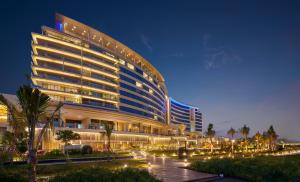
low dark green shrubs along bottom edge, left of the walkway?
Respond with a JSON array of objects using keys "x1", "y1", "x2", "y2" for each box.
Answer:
[{"x1": 50, "y1": 167, "x2": 160, "y2": 182}]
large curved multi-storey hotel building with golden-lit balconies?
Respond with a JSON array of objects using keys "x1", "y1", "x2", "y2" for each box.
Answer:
[{"x1": 0, "y1": 14, "x2": 202, "y2": 149}]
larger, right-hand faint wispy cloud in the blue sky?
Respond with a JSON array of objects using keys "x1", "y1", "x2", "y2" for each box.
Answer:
[{"x1": 202, "y1": 34, "x2": 243, "y2": 70}]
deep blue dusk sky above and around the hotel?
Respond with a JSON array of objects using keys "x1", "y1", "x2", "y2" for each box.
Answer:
[{"x1": 0, "y1": 0, "x2": 300, "y2": 140}]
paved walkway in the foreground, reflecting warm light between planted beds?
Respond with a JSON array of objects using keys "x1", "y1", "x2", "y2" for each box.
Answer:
[{"x1": 146, "y1": 156, "x2": 216, "y2": 182}]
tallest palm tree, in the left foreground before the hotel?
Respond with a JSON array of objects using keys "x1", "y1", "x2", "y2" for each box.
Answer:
[{"x1": 0, "y1": 85, "x2": 63, "y2": 182}]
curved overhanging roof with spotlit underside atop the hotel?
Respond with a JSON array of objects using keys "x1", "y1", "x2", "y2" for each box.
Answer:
[{"x1": 55, "y1": 13, "x2": 165, "y2": 82}]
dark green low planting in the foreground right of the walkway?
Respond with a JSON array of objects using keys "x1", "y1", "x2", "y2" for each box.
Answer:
[{"x1": 190, "y1": 155, "x2": 300, "y2": 182}]
